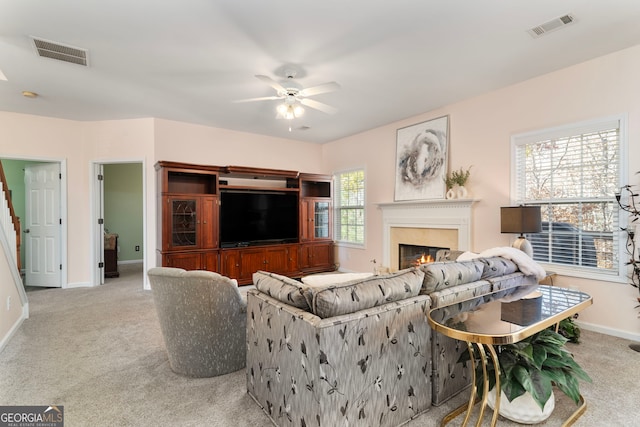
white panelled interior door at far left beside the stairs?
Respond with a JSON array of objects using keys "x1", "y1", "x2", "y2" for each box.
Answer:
[{"x1": 23, "y1": 163, "x2": 62, "y2": 287}]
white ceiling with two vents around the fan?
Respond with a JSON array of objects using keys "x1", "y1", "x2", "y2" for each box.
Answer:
[{"x1": 0, "y1": 0, "x2": 640, "y2": 143}]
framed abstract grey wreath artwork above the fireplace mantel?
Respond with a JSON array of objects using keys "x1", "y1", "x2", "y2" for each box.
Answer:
[{"x1": 395, "y1": 116, "x2": 449, "y2": 201}]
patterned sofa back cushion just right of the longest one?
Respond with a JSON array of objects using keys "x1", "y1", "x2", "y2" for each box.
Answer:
[{"x1": 420, "y1": 259, "x2": 484, "y2": 294}]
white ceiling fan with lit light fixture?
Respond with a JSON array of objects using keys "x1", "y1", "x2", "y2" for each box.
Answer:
[{"x1": 235, "y1": 72, "x2": 340, "y2": 120}]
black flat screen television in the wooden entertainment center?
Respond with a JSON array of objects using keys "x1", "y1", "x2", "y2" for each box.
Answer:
[{"x1": 220, "y1": 190, "x2": 299, "y2": 248}]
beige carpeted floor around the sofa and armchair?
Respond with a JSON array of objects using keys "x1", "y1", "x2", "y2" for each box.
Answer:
[{"x1": 0, "y1": 265, "x2": 640, "y2": 427}]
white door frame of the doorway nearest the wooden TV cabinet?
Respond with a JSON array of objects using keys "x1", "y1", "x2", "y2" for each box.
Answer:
[{"x1": 89, "y1": 158, "x2": 149, "y2": 289}]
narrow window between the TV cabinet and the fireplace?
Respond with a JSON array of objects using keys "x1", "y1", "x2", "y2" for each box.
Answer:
[{"x1": 335, "y1": 170, "x2": 364, "y2": 245}]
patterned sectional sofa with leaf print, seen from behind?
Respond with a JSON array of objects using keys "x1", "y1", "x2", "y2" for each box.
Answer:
[{"x1": 246, "y1": 257, "x2": 537, "y2": 427}]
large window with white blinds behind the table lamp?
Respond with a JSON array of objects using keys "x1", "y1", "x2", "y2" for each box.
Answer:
[{"x1": 512, "y1": 118, "x2": 626, "y2": 281}]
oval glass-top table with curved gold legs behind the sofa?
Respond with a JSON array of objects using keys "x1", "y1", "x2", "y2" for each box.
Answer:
[{"x1": 427, "y1": 285, "x2": 593, "y2": 426}]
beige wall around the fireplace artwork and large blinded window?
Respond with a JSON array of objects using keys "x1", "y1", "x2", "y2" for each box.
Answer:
[{"x1": 323, "y1": 46, "x2": 640, "y2": 339}]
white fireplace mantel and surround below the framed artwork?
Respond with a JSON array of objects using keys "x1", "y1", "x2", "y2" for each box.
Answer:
[{"x1": 378, "y1": 199, "x2": 477, "y2": 266}]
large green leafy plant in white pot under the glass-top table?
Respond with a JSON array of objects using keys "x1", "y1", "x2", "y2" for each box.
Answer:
[{"x1": 461, "y1": 329, "x2": 591, "y2": 409}]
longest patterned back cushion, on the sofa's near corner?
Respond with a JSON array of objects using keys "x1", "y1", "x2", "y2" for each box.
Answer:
[{"x1": 307, "y1": 267, "x2": 424, "y2": 318}]
